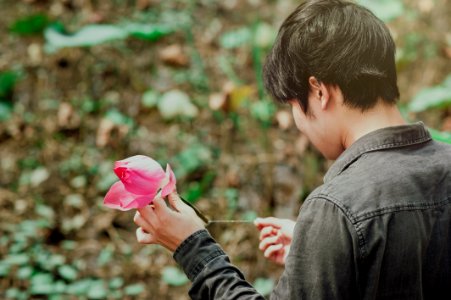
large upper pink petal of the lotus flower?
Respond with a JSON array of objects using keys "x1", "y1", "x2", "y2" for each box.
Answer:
[{"x1": 114, "y1": 155, "x2": 166, "y2": 195}]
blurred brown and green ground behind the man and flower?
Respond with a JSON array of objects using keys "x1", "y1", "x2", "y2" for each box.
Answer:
[{"x1": 0, "y1": 0, "x2": 451, "y2": 299}]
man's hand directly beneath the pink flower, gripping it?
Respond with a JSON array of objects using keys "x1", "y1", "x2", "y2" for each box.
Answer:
[{"x1": 133, "y1": 192, "x2": 205, "y2": 252}]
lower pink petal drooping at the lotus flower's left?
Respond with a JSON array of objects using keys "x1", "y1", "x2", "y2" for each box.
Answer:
[{"x1": 103, "y1": 181, "x2": 155, "y2": 211}]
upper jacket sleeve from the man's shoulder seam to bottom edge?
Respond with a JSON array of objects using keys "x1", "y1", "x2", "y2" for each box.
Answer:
[{"x1": 271, "y1": 198, "x2": 359, "y2": 300}]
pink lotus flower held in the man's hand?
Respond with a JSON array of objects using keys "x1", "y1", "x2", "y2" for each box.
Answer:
[{"x1": 103, "y1": 155, "x2": 176, "y2": 211}]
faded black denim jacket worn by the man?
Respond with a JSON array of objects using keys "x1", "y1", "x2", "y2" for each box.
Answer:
[{"x1": 174, "y1": 123, "x2": 451, "y2": 300}]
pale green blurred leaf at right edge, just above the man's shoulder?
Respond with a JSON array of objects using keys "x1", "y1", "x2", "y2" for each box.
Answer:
[{"x1": 408, "y1": 76, "x2": 451, "y2": 112}]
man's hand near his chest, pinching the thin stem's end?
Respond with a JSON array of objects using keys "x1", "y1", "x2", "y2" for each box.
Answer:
[{"x1": 254, "y1": 217, "x2": 295, "y2": 265}]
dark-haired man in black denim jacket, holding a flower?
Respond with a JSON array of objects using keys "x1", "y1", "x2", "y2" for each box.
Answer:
[{"x1": 135, "y1": 0, "x2": 451, "y2": 299}]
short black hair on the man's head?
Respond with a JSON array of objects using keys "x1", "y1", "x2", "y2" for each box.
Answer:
[{"x1": 263, "y1": 0, "x2": 399, "y2": 112}]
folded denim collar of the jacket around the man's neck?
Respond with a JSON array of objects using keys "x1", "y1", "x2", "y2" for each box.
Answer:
[{"x1": 324, "y1": 122, "x2": 431, "y2": 182}]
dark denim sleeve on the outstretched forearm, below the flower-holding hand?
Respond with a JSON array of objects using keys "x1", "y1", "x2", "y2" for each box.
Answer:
[{"x1": 174, "y1": 229, "x2": 264, "y2": 300}]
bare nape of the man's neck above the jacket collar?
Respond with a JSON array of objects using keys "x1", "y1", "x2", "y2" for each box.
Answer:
[{"x1": 342, "y1": 102, "x2": 406, "y2": 149}]
